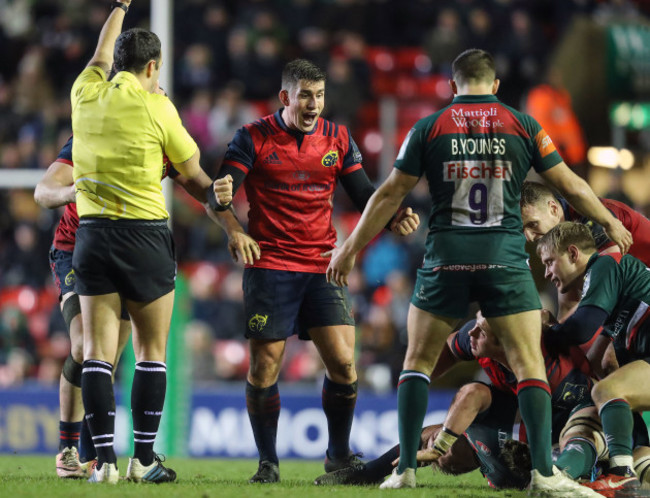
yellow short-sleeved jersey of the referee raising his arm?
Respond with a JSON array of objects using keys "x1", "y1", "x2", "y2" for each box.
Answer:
[{"x1": 70, "y1": 66, "x2": 197, "y2": 220}]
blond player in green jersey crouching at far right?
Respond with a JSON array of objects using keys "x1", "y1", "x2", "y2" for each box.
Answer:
[{"x1": 537, "y1": 222, "x2": 650, "y2": 495}]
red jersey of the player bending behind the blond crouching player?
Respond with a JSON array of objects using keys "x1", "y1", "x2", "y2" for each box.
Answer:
[{"x1": 559, "y1": 198, "x2": 650, "y2": 266}]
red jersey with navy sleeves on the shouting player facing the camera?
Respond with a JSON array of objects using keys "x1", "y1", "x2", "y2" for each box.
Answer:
[{"x1": 224, "y1": 111, "x2": 362, "y2": 273}]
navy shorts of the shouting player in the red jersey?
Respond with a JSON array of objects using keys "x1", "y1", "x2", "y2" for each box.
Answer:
[{"x1": 244, "y1": 268, "x2": 354, "y2": 340}]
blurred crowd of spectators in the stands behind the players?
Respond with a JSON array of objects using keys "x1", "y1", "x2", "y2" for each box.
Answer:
[{"x1": 0, "y1": 0, "x2": 647, "y2": 391}]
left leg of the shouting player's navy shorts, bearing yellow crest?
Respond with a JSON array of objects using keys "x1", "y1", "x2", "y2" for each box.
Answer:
[{"x1": 243, "y1": 268, "x2": 308, "y2": 341}]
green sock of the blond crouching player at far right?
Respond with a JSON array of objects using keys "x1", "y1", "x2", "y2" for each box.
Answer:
[{"x1": 598, "y1": 398, "x2": 634, "y2": 467}]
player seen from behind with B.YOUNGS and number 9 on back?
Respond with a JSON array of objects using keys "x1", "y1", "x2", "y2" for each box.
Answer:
[{"x1": 327, "y1": 49, "x2": 632, "y2": 493}]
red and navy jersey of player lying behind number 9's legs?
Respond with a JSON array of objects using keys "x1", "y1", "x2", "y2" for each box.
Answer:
[{"x1": 452, "y1": 320, "x2": 593, "y2": 409}]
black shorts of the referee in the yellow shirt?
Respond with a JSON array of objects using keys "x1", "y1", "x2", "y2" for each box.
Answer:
[{"x1": 72, "y1": 218, "x2": 176, "y2": 302}]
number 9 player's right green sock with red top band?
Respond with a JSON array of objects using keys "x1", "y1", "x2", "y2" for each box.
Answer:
[{"x1": 517, "y1": 379, "x2": 553, "y2": 476}]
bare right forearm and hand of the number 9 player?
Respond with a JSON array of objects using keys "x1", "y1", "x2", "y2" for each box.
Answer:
[{"x1": 541, "y1": 162, "x2": 633, "y2": 254}]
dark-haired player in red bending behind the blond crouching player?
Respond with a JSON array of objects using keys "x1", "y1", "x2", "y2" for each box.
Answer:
[{"x1": 519, "y1": 182, "x2": 650, "y2": 321}]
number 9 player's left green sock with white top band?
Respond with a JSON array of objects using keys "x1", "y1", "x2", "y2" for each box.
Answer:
[{"x1": 397, "y1": 370, "x2": 431, "y2": 474}]
